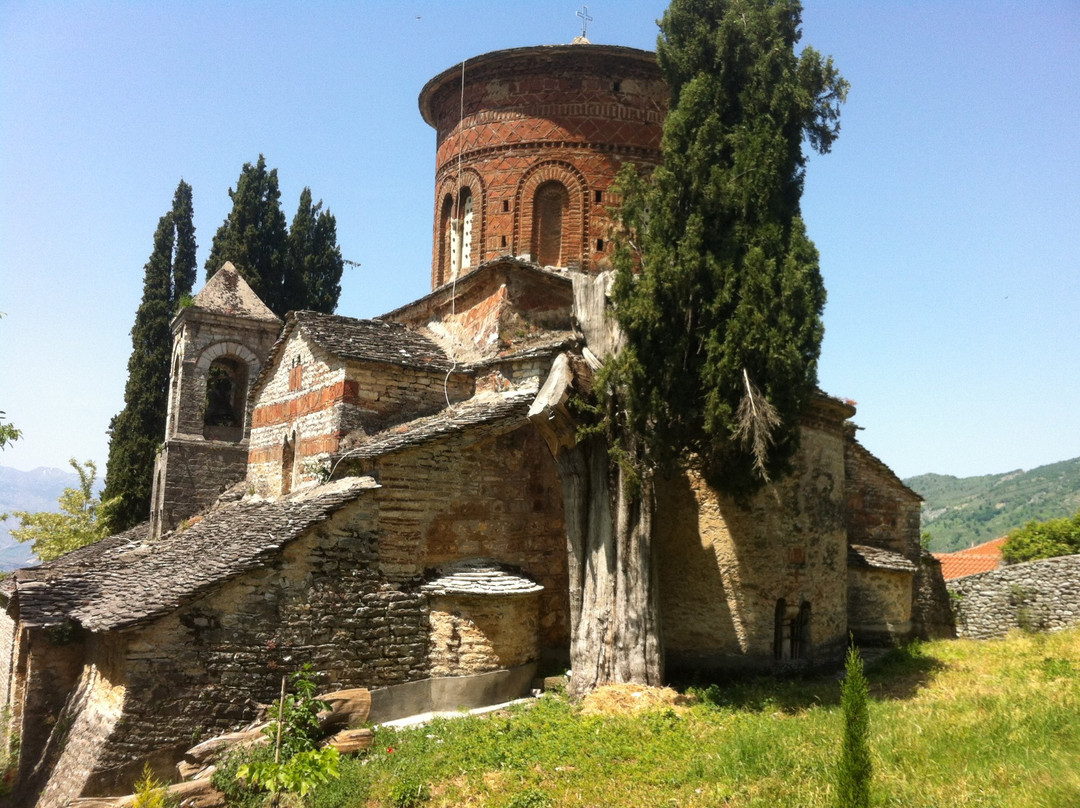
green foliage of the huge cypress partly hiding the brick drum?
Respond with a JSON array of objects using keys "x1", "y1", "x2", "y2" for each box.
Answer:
[{"x1": 608, "y1": 0, "x2": 848, "y2": 495}]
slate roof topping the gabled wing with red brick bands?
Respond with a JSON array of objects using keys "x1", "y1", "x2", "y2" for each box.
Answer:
[{"x1": 289, "y1": 311, "x2": 454, "y2": 373}]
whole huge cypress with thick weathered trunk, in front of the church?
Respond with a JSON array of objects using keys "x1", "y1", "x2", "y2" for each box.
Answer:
[{"x1": 534, "y1": 0, "x2": 847, "y2": 696}]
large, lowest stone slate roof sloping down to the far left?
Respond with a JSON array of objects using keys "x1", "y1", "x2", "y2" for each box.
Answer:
[{"x1": 4, "y1": 477, "x2": 378, "y2": 631}]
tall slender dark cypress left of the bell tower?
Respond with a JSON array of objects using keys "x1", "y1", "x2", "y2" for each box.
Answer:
[{"x1": 102, "y1": 179, "x2": 197, "y2": 531}]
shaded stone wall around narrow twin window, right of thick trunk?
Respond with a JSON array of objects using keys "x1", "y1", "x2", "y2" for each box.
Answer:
[{"x1": 656, "y1": 416, "x2": 847, "y2": 670}]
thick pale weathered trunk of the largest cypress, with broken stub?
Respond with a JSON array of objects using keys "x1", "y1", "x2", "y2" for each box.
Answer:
[{"x1": 529, "y1": 355, "x2": 663, "y2": 698}]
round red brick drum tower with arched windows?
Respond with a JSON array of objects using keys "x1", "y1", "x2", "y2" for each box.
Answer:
[{"x1": 420, "y1": 41, "x2": 669, "y2": 288}]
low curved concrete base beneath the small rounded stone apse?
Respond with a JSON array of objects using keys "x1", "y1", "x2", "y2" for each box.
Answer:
[{"x1": 368, "y1": 662, "x2": 537, "y2": 724}]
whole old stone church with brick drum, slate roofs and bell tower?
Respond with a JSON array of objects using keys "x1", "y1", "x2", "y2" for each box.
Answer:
[{"x1": 0, "y1": 42, "x2": 944, "y2": 808}]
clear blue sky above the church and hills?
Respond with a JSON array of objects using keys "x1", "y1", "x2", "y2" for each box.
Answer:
[{"x1": 0, "y1": 0, "x2": 1080, "y2": 476}]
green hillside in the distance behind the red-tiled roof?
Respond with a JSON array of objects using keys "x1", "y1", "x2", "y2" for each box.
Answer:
[{"x1": 904, "y1": 457, "x2": 1080, "y2": 552}]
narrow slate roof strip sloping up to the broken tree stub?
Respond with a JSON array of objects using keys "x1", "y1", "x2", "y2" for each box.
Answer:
[{"x1": 341, "y1": 388, "x2": 537, "y2": 460}]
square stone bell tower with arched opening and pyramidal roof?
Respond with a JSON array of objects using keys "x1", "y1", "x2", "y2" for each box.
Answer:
[{"x1": 150, "y1": 264, "x2": 281, "y2": 536}]
